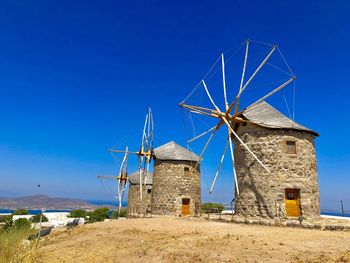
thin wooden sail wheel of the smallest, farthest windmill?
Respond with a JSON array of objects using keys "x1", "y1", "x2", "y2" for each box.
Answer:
[{"x1": 97, "y1": 147, "x2": 128, "y2": 215}]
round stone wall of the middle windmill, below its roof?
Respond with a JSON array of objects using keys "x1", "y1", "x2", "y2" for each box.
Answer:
[{"x1": 152, "y1": 160, "x2": 201, "y2": 216}]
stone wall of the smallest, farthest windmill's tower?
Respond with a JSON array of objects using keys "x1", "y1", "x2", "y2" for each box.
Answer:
[{"x1": 128, "y1": 184, "x2": 152, "y2": 216}]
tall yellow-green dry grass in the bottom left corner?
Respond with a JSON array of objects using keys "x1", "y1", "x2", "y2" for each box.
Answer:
[{"x1": 0, "y1": 228, "x2": 38, "y2": 263}]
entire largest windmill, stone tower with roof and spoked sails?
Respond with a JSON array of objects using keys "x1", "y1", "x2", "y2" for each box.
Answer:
[{"x1": 180, "y1": 40, "x2": 319, "y2": 218}]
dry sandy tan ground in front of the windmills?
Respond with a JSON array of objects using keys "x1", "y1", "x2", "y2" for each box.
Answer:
[{"x1": 39, "y1": 218, "x2": 350, "y2": 263}]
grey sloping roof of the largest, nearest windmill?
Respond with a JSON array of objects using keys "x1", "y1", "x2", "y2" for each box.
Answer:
[{"x1": 242, "y1": 101, "x2": 319, "y2": 136}]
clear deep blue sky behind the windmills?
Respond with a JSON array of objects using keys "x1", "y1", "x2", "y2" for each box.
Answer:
[{"x1": 0, "y1": 0, "x2": 350, "y2": 209}]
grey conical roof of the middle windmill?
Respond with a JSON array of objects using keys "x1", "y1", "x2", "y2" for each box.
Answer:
[{"x1": 154, "y1": 141, "x2": 199, "y2": 162}]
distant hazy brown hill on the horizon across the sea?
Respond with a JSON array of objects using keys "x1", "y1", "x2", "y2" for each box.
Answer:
[{"x1": 0, "y1": 195, "x2": 115, "y2": 210}]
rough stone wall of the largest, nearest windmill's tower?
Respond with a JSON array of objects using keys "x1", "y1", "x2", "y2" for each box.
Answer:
[{"x1": 234, "y1": 124, "x2": 320, "y2": 218}]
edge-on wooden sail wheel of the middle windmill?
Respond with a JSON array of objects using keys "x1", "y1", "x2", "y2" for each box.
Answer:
[{"x1": 109, "y1": 108, "x2": 154, "y2": 201}]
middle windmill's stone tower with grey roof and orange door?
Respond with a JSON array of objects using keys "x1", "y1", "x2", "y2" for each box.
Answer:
[{"x1": 152, "y1": 141, "x2": 201, "y2": 216}]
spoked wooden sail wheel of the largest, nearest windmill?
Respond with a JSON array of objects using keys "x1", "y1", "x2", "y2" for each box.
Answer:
[{"x1": 179, "y1": 40, "x2": 296, "y2": 198}]
